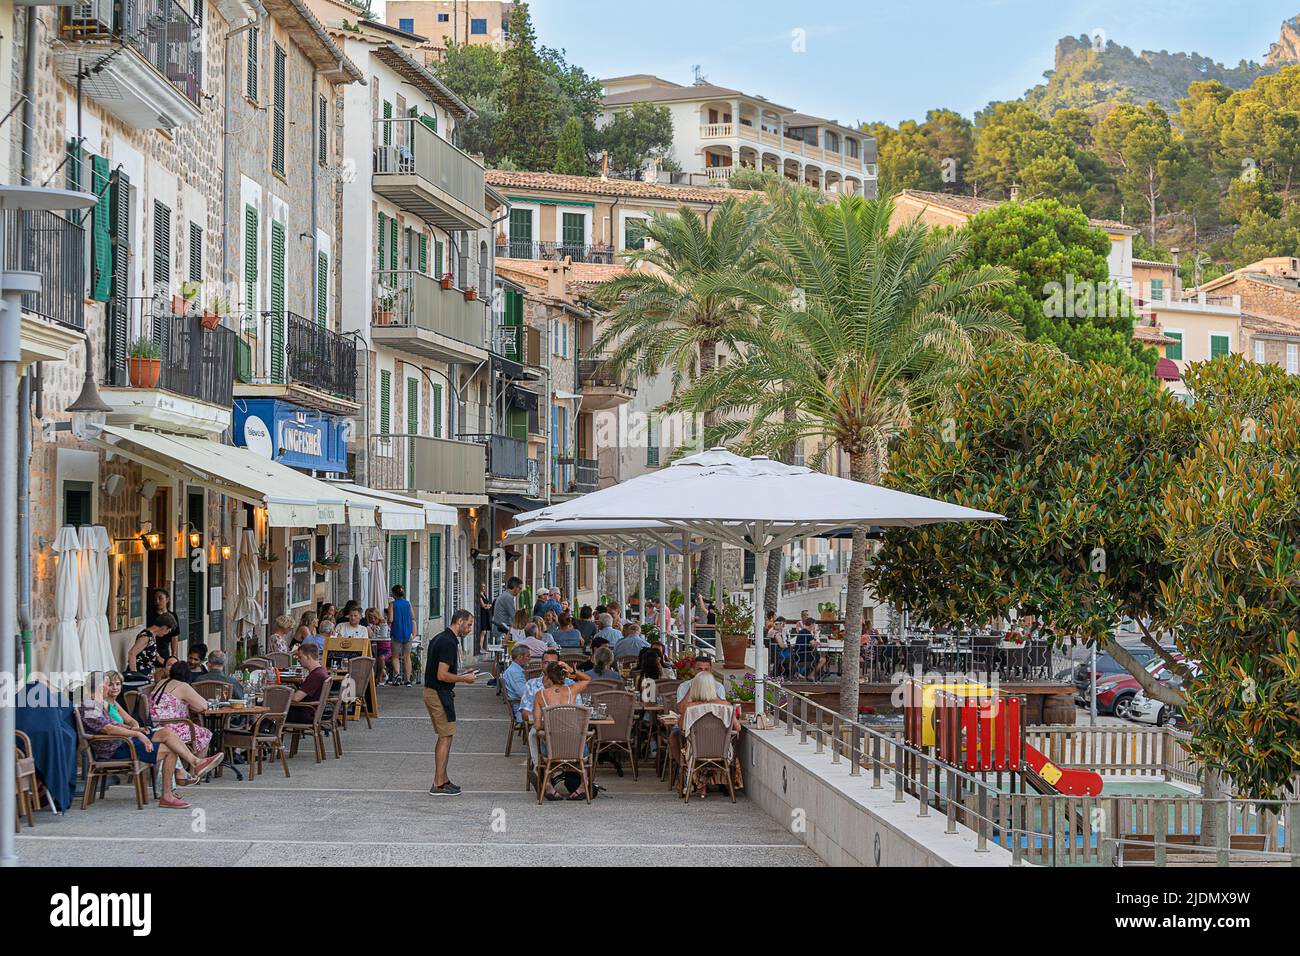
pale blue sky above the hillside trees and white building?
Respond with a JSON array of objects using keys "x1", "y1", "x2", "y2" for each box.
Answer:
[{"x1": 517, "y1": 0, "x2": 1300, "y2": 125}]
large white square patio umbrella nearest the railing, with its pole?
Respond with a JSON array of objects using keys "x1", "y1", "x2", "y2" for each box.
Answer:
[{"x1": 516, "y1": 449, "x2": 1002, "y2": 713}]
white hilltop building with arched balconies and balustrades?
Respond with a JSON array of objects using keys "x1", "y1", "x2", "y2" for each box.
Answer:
[{"x1": 601, "y1": 74, "x2": 876, "y2": 196}]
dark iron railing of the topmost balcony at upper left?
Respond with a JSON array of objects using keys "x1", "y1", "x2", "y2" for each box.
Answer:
[{"x1": 60, "y1": 0, "x2": 203, "y2": 107}]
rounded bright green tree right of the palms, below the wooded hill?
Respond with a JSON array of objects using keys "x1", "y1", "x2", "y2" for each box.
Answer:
[{"x1": 966, "y1": 199, "x2": 1156, "y2": 376}]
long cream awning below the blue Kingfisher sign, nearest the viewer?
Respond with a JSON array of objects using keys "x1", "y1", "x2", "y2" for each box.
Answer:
[{"x1": 94, "y1": 425, "x2": 353, "y2": 528}]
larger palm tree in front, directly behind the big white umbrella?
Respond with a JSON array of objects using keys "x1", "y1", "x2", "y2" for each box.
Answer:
[{"x1": 672, "y1": 195, "x2": 1015, "y2": 718}]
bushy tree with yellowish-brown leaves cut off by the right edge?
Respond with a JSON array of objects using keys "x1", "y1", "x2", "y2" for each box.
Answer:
[{"x1": 1161, "y1": 355, "x2": 1300, "y2": 799}]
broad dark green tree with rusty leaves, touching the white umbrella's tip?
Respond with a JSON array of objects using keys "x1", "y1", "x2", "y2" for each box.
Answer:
[{"x1": 867, "y1": 345, "x2": 1190, "y2": 704}]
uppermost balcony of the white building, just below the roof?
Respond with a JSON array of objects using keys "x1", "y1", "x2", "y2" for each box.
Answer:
[{"x1": 371, "y1": 117, "x2": 489, "y2": 230}]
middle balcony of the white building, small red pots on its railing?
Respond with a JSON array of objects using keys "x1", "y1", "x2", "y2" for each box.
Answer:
[{"x1": 371, "y1": 269, "x2": 488, "y2": 362}]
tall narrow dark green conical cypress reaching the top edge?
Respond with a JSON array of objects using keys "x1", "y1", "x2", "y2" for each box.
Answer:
[{"x1": 497, "y1": 3, "x2": 559, "y2": 169}]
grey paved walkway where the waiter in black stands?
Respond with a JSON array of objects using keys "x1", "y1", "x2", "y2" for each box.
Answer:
[{"x1": 18, "y1": 665, "x2": 819, "y2": 866}]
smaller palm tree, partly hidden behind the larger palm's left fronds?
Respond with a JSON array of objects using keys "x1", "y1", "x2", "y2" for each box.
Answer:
[{"x1": 594, "y1": 198, "x2": 767, "y2": 600}]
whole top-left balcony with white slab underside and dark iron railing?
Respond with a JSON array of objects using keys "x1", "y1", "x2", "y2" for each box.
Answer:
[{"x1": 53, "y1": 0, "x2": 203, "y2": 129}]
